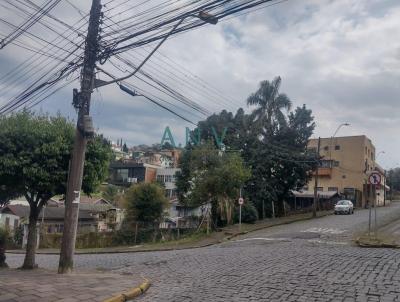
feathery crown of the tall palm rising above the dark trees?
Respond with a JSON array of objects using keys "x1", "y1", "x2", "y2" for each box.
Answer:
[{"x1": 247, "y1": 77, "x2": 292, "y2": 136}]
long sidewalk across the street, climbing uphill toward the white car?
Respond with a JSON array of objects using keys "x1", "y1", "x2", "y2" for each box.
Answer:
[{"x1": 7, "y1": 211, "x2": 333, "y2": 254}]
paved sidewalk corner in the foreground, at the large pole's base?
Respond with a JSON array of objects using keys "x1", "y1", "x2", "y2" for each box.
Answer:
[{"x1": 0, "y1": 269, "x2": 143, "y2": 302}]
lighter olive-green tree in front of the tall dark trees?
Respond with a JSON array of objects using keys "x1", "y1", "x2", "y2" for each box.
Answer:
[{"x1": 176, "y1": 142, "x2": 250, "y2": 226}]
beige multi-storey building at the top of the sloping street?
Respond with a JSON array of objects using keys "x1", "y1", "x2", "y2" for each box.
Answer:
[{"x1": 307, "y1": 135, "x2": 386, "y2": 207}]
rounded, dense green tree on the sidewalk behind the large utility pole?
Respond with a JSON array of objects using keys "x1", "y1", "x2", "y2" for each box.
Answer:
[{"x1": 0, "y1": 111, "x2": 111, "y2": 269}]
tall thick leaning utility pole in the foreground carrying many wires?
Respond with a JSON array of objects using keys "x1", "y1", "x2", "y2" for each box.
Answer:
[{"x1": 58, "y1": 0, "x2": 101, "y2": 273}]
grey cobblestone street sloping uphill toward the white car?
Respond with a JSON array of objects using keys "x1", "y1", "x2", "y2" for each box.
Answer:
[{"x1": 8, "y1": 204, "x2": 400, "y2": 302}]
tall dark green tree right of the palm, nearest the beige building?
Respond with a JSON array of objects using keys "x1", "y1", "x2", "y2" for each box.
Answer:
[{"x1": 246, "y1": 106, "x2": 316, "y2": 217}]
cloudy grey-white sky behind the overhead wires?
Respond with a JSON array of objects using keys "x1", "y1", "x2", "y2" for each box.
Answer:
[{"x1": 0, "y1": 0, "x2": 400, "y2": 168}]
